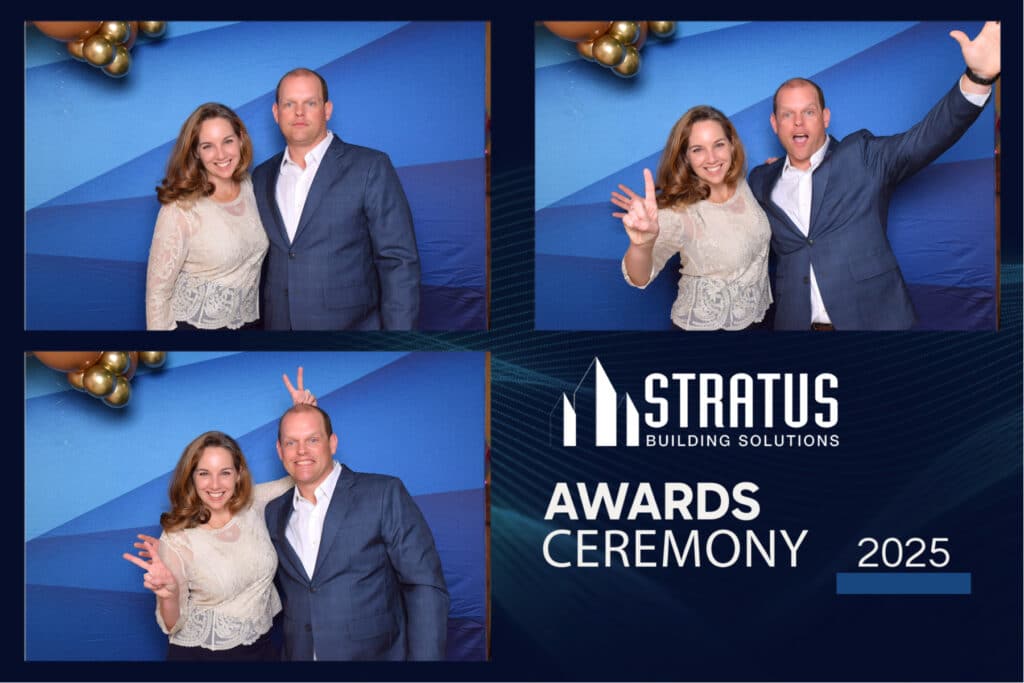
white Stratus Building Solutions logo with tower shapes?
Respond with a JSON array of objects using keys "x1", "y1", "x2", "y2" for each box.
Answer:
[{"x1": 552, "y1": 356, "x2": 839, "y2": 447}]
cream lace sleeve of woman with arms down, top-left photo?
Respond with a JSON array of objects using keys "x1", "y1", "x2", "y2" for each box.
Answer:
[{"x1": 145, "y1": 203, "x2": 190, "y2": 330}]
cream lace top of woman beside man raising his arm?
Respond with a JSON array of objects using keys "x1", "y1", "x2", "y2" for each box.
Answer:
[{"x1": 623, "y1": 180, "x2": 772, "y2": 330}]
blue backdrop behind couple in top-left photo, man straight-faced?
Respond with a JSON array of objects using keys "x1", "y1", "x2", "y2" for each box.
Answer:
[{"x1": 25, "y1": 22, "x2": 486, "y2": 330}]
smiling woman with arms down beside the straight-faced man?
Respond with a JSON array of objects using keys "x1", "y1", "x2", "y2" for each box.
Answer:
[{"x1": 145, "y1": 102, "x2": 268, "y2": 330}]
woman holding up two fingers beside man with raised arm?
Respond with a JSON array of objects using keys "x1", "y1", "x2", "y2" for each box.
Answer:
[{"x1": 611, "y1": 105, "x2": 772, "y2": 330}]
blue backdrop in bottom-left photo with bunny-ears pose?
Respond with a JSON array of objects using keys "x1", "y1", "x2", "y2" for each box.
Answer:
[{"x1": 25, "y1": 351, "x2": 485, "y2": 661}]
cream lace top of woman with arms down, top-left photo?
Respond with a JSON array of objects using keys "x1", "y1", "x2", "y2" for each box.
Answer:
[{"x1": 145, "y1": 178, "x2": 269, "y2": 330}]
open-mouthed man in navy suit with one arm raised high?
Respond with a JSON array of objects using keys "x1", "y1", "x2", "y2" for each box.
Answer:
[{"x1": 750, "y1": 22, "x2": 999, "y2": 330}]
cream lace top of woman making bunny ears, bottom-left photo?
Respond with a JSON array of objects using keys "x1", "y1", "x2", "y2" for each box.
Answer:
[{"x1": 157, "y1": 477, "x2": 295, "y2": 650}]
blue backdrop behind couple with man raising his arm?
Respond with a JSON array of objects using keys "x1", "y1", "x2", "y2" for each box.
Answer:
[{"x1": 535, "y1": 22, "x2": 997, "y2": 330}]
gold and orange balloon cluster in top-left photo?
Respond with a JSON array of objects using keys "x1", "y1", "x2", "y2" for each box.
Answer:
[{"x1": 33, "y1": 22, "x2": 167, "y2": 78}]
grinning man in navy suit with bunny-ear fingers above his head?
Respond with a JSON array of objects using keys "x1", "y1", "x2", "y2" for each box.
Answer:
[{"x1": 266, "y1": 404, "x2": 449, "y2": 660}]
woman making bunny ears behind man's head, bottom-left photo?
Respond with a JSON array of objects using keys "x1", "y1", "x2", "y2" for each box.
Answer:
[{"x1": 122, "y1": 368, "x2": 316, "y2": 660}]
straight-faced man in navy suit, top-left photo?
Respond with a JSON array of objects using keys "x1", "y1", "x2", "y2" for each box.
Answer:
[{"x1": 253, "y1": 69, "x2": 420, "y2": 330}]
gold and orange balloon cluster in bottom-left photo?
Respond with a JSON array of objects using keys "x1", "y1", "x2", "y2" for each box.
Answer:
[{"x1": 34, "y1": 351, "x2": 167, "y2": 408}]
